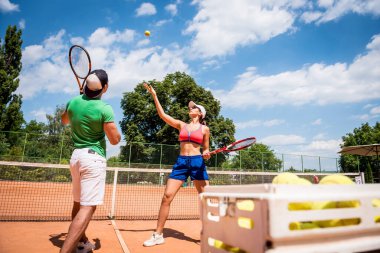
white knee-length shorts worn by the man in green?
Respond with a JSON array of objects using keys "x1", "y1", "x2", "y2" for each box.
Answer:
[{"x1": 70, "y1": 148, "x2": 107, "y2": 206}]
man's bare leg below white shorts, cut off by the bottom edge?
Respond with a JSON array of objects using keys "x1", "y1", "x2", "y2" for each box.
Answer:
[{"x1": 60, "y1": 206, "x2": 96, "y2": 253}]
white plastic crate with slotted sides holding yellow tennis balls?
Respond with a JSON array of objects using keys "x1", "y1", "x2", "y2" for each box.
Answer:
[{"x1": 200, "y1": 184, "x2": 380, "y2": 253}]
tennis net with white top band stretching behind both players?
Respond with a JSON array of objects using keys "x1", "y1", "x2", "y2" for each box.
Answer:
[{"x1": 0, "y1": 161, "x2": 359, "y2": 221}]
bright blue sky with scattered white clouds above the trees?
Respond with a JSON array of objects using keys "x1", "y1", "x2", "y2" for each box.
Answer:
[{"x1": 0, "y1": 0, "x2": 380, "y2": 157}]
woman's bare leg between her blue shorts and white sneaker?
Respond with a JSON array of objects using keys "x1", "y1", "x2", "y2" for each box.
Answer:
[{"x1": 156, "y1": 178, "x2": 183, "y2": 234}]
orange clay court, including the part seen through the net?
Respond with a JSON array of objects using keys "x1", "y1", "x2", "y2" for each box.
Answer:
[{"x1": 0, "y1": 181, "x2": 201, "y2": 253}]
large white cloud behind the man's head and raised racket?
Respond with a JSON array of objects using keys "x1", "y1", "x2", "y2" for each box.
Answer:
[{"x1": 17, "y1": 28, "x2": 190, "y2": 99}]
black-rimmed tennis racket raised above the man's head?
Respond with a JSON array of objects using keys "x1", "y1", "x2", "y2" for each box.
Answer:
[{"x1": 69, "y1": 45, "x2": 91, "y2": 94}]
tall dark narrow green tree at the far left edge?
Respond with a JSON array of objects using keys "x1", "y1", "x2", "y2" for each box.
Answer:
[{"x1": 0, "y1": 26, "x2": 24, "y2": 133}]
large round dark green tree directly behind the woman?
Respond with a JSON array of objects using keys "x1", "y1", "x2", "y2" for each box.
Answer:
[{"x1": 120, "y1": 72, "x2": 235, "y2": 165}]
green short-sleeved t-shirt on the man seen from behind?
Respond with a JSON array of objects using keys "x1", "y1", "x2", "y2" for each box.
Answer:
[{"x1": 66, "y1": 95, "x2": 114, "y2": 157}]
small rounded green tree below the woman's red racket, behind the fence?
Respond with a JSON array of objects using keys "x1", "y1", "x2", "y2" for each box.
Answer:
[{"x1": 229, "y1": 143, "x2": 282, "y2": 171}]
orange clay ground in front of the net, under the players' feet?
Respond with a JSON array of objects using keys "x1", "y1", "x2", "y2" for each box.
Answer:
[{"x1": 0, "y1": 220, "x2": 201, "y2": 253}]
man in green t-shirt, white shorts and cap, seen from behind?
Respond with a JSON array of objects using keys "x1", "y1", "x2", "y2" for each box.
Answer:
[{"x1": 60, "y1": 69, "x2": 121, "y2": 253}]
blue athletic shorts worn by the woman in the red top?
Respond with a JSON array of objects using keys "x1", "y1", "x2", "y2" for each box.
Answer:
[{"x1": 169, "y1": 155, "x2": 208, "y2": 181}]
